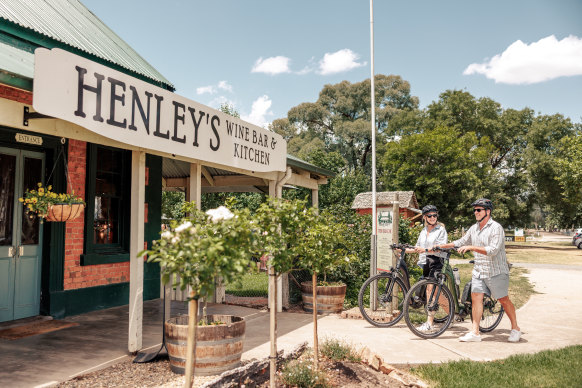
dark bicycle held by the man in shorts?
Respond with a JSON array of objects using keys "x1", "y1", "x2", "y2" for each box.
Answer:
[{"x1": 403, "y1": 248, "x2": 505, "y2": 339}]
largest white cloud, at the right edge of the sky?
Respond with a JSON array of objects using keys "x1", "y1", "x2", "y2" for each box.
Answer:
[{"x1": 463, "y1": 35, "x2": 582, "y2": 85}]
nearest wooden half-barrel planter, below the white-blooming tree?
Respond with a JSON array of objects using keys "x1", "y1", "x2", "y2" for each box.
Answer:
[{"x1": 164, "y1": 315, "x2": 246, "y2": 376}]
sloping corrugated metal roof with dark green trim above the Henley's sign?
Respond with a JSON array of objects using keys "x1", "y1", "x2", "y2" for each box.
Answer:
[{"x1": 0, "y1": 0, "x2": 175, "y2": 92}]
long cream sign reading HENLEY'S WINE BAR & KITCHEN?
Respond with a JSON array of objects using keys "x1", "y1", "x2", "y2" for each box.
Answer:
[{"x1": 33, "y1": 48, "x2": 287, "y2": 172}]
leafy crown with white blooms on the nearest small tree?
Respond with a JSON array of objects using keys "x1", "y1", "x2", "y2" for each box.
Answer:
[{"x1": 141, "y1": 202, "x2": 256, "y2": 299}]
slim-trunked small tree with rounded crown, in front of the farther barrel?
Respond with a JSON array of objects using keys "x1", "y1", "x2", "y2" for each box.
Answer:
[{"x1": 296, "y1": 211, "x2": 352, "y2": 369}]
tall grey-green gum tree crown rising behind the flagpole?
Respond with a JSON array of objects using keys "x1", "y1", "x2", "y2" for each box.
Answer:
[{"x1": 271, "y1": 74, "x2": 418, "y2": 171}]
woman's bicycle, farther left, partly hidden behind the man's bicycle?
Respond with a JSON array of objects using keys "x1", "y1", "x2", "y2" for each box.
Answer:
[{"x1": 358, "y1": 244, "x2": 422, "y2": 327}]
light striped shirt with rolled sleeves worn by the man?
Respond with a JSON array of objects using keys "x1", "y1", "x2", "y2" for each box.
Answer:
[{"x1": 453, "y1": 218, "x2": 509, "y2": 279}]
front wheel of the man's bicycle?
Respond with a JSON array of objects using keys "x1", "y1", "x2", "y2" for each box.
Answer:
[{"x1": 404, "y1": 279, "x2": 455, "y2": 338}]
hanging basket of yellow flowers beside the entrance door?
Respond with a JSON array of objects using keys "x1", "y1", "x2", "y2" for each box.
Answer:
[{"x1": 19, "y1": 183, "x2": 85, "y2": 222}]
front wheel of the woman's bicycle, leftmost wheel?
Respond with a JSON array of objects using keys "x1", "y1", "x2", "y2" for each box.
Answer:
[{"x1": 358, "y1": 273, "x2": 407, "y2": 327}]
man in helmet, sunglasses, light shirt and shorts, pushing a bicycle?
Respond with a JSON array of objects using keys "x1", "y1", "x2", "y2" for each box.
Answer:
[{"x1": 439, "y1": 198, "x2": 521, "y2": 342}]
